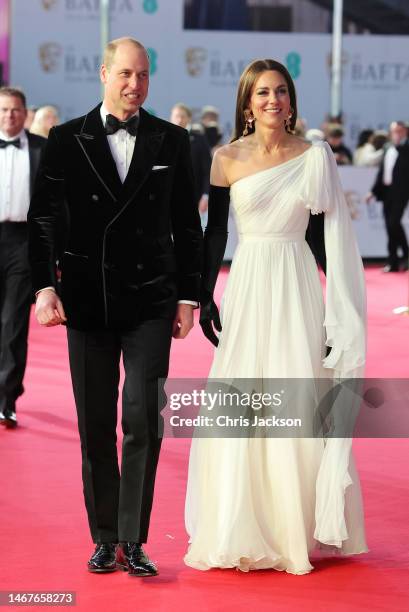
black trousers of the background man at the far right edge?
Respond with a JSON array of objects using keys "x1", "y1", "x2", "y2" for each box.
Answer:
[{"x1": 383, "y1": 190, "x2": 409, "y2": 267}]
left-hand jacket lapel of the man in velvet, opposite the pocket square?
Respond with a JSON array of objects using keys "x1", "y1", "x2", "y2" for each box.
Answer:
[{"x1": 75, "y1": 104, "x2": 122, "y2": 202}]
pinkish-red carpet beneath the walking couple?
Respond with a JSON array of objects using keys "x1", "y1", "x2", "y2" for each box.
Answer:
[{"x1": 0, "y1": 269, "x2": 409, "y2": 612}]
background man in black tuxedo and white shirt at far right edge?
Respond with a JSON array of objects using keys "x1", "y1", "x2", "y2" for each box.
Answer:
[{"x1": 366, "y1": 121, "x2": 409, "y2": 272}]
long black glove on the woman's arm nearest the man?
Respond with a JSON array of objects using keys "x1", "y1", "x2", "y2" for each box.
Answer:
[{"x1": 199, "y1": 185, "x2": 230, "y2": 346}]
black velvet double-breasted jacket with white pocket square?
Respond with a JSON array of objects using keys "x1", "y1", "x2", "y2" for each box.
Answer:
[{"x1": 28, "y1": 105, "x2": 202, "y2": 331}]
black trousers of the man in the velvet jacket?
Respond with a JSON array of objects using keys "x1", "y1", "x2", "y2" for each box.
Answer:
[{"x1": 67, "y1": 319, "x2": 172, "y2": 543}]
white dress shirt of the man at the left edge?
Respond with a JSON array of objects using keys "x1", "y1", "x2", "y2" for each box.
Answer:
[{"x1": 0, "y1": 130, "x2": 30, "y2": 223}]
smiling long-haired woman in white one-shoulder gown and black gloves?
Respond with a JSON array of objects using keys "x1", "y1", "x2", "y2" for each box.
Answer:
[{"x1": 184, "y1": 60, "x2": 367, "y2": 574}]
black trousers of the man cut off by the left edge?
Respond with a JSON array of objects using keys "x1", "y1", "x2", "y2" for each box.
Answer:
[{"x1": 0, "y1": 221, "x2": 31, "y2": 415}]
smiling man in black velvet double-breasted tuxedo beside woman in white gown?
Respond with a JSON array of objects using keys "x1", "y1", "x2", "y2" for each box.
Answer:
[{"x1": 29, "y1": 38, "x2": 202, "y2": 576}]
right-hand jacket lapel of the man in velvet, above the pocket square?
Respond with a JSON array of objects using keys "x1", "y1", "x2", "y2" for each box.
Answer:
[{"x1": 121, "y1": 108, "x2": 165, "y2": 203}]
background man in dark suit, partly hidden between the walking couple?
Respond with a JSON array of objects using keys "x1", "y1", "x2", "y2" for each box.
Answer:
[{"x1": 170, "y1": 102, "x2": 212, "y2": 213}]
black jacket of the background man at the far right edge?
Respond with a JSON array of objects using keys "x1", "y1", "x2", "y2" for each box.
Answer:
[{"x1": 371, "y1": 140, "x2": 409, "y2": 204}]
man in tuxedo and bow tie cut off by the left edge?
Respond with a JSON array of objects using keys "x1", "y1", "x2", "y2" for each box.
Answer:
[{"x1": 0, "y1": 87, "x2": 46, "y2": 428}]
